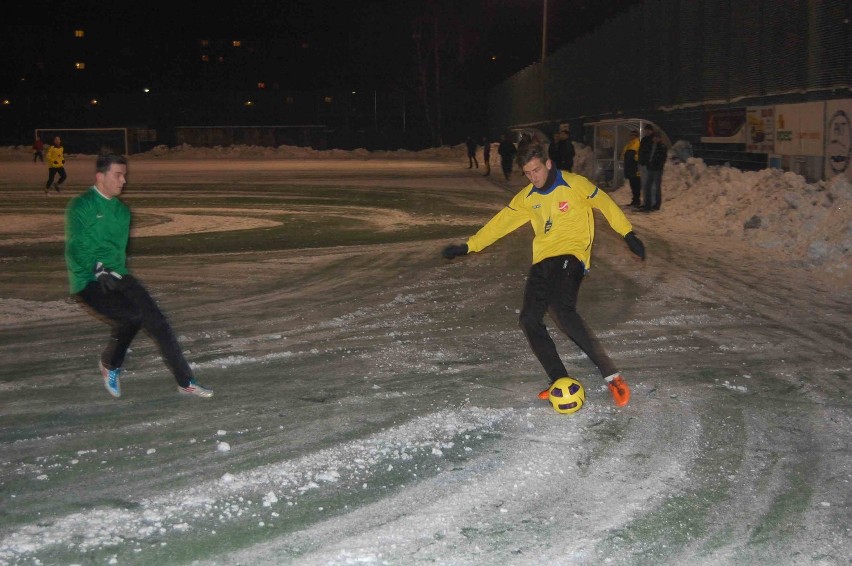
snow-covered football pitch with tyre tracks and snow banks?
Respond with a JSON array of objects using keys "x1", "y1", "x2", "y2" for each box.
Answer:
[{"x1": 0, "y1": 147, "x2": 852, "y2": 566}]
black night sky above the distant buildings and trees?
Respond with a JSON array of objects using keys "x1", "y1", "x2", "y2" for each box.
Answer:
[{"x1": 0, "y1": 0, "x2": 641, "y2": 90}]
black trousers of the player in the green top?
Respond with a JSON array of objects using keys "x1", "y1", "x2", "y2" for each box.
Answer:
[{"x1": 77, "y1": 275, "x2": 192, "y2": 387}]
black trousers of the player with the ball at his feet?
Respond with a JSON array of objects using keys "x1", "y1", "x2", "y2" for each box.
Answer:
[{"x1": 519, "y1": 255, "x2": 617, "y2": 382}]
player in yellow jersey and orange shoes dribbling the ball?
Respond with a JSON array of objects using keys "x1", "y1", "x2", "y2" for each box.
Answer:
[{"x1": 442, "y1": 143, "x2": 645, "y2": 407}]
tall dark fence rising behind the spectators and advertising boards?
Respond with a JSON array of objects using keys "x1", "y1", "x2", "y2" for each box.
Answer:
[{"x1": 488, "y1": 0, "x2": 852, "y2": 178}]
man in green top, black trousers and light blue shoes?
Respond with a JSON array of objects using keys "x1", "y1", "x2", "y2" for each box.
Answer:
[{"x1": 65, "y1": 154, "x2": 213, "y2": 397}]
